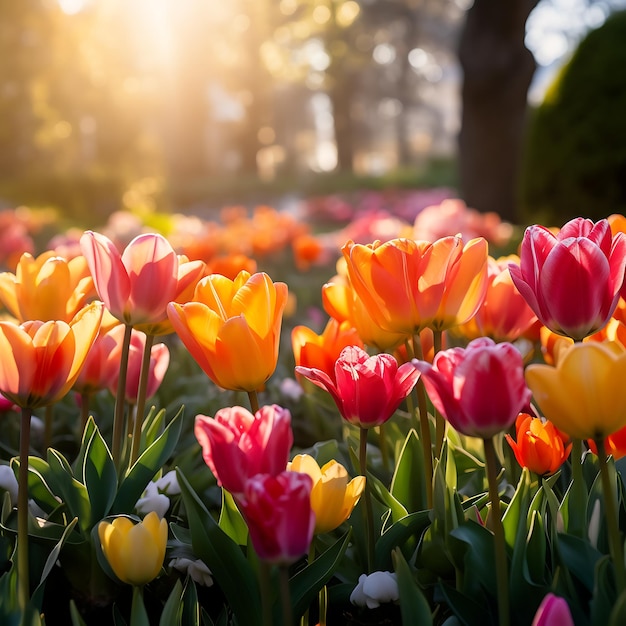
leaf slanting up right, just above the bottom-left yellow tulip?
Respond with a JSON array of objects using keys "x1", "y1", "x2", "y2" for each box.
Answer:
[{"x1": 111, "y1": 407, "x2": 183, "y2": 514}]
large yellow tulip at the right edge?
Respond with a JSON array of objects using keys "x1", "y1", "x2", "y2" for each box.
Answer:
[{"x1": 526, "y1": 342, "x2": 626, "y2": 439}]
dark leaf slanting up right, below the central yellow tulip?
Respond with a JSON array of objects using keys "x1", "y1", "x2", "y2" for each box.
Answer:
[{"x1": 284, "y1": 530, "x2": 351, "y2": 621}]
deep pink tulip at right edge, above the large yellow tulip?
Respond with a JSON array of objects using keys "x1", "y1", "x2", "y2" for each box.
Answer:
[{"x1": 509, "y1": 217, "x2": 626, "y2": 341}]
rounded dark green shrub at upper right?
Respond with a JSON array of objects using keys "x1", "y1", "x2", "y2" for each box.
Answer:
[{"x1": 521, "y1": 11, "x2": 626, "y2": 226}]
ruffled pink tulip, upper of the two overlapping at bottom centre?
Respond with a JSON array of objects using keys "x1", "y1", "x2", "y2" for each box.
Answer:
[{"x1": 194, "y1": 404, "x2": 293, "y2": 494}]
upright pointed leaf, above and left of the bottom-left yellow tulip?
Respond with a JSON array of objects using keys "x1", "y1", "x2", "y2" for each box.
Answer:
[{"x1": 82, "y1": 427, "x2": 117, "y2": 523}]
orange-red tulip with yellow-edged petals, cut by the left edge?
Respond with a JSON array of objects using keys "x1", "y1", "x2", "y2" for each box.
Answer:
[{"x1": 0, "y1": 302, "x2": 103, "y2": 409}]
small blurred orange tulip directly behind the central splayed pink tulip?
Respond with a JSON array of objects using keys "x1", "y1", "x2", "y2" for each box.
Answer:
[{"x1": 291, "y1": 318, "x2": 363, "y2": 378}]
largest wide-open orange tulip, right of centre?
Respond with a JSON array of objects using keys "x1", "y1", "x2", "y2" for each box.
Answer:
[{"x1": 342, "y1": 237, "x2": 487, "y2": 335}]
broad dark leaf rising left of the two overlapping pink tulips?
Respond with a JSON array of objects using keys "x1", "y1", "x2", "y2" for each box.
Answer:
[{"x1": 176, "y1": 470, "x2": 262, "y2": 626}]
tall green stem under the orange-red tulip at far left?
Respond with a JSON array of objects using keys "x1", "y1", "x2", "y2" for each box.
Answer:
[{"x1": 17, "y1": 408, "x2": 32, "y2": 611}]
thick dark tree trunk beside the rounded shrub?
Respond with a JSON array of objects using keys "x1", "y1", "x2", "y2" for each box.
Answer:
[{"x1": 459, "y1": 0, "x2": 538, "y2": 223}]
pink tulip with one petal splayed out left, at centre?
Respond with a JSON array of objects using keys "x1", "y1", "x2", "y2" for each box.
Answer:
[{"x1": 296, "y1": 346, "x2": 419, "y2": 428}]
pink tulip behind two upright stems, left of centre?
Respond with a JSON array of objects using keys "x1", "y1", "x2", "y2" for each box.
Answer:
[{"x1": 105, "y1": 324, "x2": 170, "y2": 404}]
